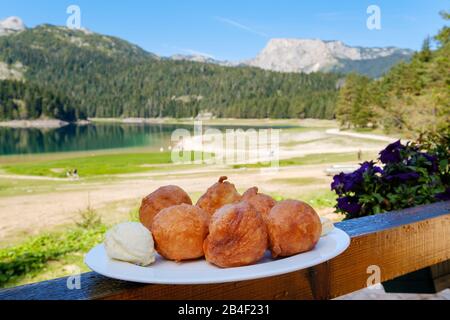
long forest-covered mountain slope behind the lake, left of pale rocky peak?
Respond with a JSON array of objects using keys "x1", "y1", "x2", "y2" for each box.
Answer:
[{"x1": 0, "y1": 19, "x2": 342, "y2": 119}]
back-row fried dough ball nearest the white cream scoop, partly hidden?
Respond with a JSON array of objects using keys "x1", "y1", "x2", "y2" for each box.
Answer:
[{"x1": 139, "y1": 186, "x2": 192, "y2": 231}]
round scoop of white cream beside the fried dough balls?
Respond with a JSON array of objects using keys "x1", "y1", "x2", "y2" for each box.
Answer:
[{"x1": 105, "y1": 222, "x2": 155, "y2": 266}]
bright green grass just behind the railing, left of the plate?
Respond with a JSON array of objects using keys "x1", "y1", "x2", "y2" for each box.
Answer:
[{"x1": 0, "y1": 208, "x2": 108, "y2": 288}]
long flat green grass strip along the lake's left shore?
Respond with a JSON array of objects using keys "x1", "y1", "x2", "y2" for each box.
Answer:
[{"x1": 2, "y1": 152, "x2": 213, "y2": 178}]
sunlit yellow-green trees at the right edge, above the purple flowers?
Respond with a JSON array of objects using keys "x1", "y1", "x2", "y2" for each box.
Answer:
[{"x1": 336, "y1": 13, "x2": 450, "y2": 137}]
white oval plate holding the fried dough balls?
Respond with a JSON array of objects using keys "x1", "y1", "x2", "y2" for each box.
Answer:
[{"x1": 85, "y1": 228, "x2": 350, "y2": 285}]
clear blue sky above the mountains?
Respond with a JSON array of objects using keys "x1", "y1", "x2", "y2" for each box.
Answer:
[{"x1": 0, "y1": 0, "x2": 450, "y2": 60}]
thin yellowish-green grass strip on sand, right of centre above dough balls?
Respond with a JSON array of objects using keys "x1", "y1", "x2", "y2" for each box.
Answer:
[{"x1": 233, "y1": 152, "x2": 376, "y2": 169}]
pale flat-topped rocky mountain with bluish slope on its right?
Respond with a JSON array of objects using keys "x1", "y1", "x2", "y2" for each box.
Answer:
[{"x1": 248, "y1": 39, "x2": 413, "y2": 77}]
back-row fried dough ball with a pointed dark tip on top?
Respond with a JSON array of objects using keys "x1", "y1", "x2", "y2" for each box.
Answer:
[{"x1": 197, "y1": 177, "x2": 241, "y2": 216}]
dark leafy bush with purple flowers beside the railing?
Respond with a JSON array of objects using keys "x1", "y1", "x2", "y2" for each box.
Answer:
[{"x1": 331, "y1": 137, "x2": 450, "y2": 219}]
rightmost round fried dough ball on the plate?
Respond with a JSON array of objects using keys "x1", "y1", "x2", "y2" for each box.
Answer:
[{"x1": 266, "y1": 200, "x2": 322, "y2": 258}]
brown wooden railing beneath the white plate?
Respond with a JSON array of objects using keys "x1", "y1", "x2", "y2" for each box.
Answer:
[{"x1": 0, "y1": 202, "x2": 450, "y2": 300}]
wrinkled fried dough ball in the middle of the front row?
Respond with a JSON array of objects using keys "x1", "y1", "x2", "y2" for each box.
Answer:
[{"x1": 203, "y1": 201, "x2": 268, "y2": 268}]
